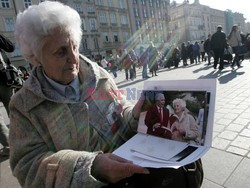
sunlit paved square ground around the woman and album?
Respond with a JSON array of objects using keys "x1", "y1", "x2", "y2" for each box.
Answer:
[{"x1": 0, "y1": 59, "x2": 250, "y2": 188}]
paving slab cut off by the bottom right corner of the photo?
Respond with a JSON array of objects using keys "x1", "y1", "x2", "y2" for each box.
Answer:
[{"x1": 225, "y1": 158, "x2": 250, "y2": 188}]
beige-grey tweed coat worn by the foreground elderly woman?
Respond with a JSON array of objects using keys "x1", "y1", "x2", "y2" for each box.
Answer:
[{"x1": 10, "y1": 56, "x2": 137, "y2": 188}]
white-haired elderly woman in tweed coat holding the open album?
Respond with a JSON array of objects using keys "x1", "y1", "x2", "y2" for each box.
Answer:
[{"x1": 9, "y1": 1, "x2": 149, "y2": 188}]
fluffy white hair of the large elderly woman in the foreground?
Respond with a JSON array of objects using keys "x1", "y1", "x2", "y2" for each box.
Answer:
[{"x1": 15, "y1": 1, "x2": 82, "y2": 66}]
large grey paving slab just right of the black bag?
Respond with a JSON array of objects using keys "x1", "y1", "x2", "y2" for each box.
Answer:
[{"x1": 202, "y1": 148, "x2": 242, "y2": 185}]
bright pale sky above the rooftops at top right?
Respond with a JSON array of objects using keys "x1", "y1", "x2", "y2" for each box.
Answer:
[{"x1": 171, "y1": 0, "x2": 250, "y2": 22}]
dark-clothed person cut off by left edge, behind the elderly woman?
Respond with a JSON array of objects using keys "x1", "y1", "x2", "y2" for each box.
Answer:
[{"x1": 0, "y1": 35, "x2": 15, "y2": 156}]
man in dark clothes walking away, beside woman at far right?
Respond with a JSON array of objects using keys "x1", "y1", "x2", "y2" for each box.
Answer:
[{"x1": 211, "y1": 25, "x2": 227, "y2": 70}]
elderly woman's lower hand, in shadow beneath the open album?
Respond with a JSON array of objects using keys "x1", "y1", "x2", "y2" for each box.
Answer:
[{"x1": 91, "y1": 153, "x2": 149, "y2": 183}]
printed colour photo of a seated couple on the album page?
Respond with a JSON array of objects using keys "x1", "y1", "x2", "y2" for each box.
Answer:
[{"x1": 138, "y1": 90, "x2": 210, "y2": 146}]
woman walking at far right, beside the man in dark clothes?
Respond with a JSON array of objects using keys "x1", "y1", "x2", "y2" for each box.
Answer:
[{"x1": 228, "y1": 25, "x2": 242, "y2": 68}]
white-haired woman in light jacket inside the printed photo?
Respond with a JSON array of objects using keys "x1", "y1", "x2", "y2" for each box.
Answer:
[{"x1": 170, "y1": 98, "x2": 199, "y2": 143}]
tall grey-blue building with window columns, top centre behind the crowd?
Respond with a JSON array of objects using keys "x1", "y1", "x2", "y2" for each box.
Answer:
[{"x1": 126, "y1": 0, "x2": 170, "y2": 49}]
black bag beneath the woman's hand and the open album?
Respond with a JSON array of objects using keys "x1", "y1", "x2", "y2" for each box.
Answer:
[{"x1": 104, "y1": 159, "x2": 204, "y2": 188}]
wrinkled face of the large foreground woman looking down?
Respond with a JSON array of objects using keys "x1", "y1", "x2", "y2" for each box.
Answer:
[{"x1": 41, "y1": 29, "x2": 79, "y2": 85}]
